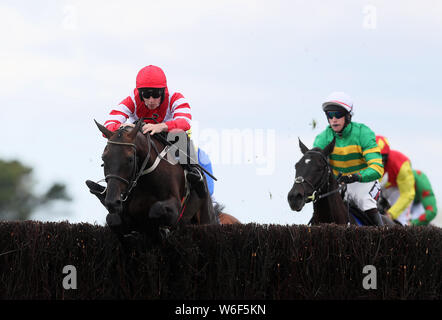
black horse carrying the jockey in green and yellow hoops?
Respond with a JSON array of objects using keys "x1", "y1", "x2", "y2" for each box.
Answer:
[{"x1": 287, "y1": 139, "x2": 395, "y2": 226}]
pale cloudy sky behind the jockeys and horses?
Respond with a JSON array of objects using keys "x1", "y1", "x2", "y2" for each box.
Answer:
[{"x1": 0, "y1": 0, "x2": 442, "y2": 226}]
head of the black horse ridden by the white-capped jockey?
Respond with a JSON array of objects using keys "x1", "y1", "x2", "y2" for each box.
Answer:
[{"x1": 287, "y1": 139, "x2": 335, "y2": 211}]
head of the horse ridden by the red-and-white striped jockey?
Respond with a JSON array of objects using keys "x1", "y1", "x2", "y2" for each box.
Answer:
[{"x1": 95, "y1": 121, "x2": 142, "y2": 214}]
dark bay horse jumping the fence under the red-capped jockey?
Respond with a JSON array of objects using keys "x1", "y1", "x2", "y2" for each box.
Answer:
[{"x1": 86, "y1": 121, "x2": 219, "y2": 240}]
